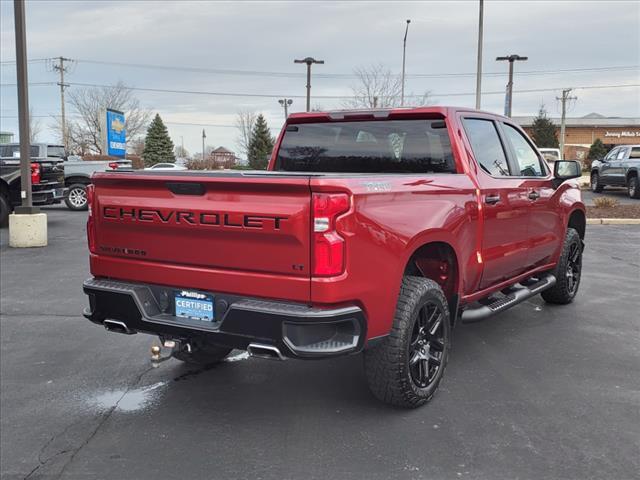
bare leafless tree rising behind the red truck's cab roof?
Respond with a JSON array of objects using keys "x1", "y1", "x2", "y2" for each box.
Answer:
[{"x1": 344, "y1": 64, "x2": 431, "y2": 108}]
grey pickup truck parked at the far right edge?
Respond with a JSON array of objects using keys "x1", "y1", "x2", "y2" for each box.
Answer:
[{"x1": 591, "y1": 145, "x2": 640, "y2": 198}]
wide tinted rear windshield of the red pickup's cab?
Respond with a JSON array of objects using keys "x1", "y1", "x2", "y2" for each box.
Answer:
[{"x1": 276, "y1": 120, "x2": 456, "y2": 173}]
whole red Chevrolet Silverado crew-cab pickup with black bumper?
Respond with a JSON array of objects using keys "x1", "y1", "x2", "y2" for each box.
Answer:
[{"x1": 84, "y1": 107, "x2": 586, "y2": 407}]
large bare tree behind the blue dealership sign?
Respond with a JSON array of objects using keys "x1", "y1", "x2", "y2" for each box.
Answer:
[{"x1": 53, "y1": 82, "x2": 151, "y2": 154}]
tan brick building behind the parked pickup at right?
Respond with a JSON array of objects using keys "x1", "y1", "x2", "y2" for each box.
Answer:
[{"x1": 513, "y1": 113, "x2": 640, "y2": 160}]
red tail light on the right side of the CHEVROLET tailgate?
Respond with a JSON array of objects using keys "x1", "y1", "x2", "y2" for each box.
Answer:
[{"x1": 312, "y1": 193, "x2": 350, "y2": 277}]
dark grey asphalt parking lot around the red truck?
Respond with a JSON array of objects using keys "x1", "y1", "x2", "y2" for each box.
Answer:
[{"x1": 0, "y1": 207, "x2": 640, "y2": 480}]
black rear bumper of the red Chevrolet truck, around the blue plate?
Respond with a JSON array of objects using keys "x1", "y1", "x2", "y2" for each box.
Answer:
[{"x1": 83, "y1": 278, "x2": 366, "y2": 358}]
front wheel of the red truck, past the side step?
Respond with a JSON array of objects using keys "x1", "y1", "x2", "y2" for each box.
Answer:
[{"x1": 540, "y1": 228, "x2": 582, "y2": 305}]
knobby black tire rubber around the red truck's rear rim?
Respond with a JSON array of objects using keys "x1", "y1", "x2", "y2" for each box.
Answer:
[{"x1": 364, "y1": 276, "x2": 451, "y2": 408}]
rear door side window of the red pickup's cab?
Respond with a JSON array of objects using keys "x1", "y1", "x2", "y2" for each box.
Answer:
[{"x1": 464, "y1": 118, "x2": 509, "y2": 177}]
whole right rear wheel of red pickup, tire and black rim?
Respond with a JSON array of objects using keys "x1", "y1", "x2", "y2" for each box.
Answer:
[{"x1": 364, "y1": 276, "x2": 451, "y2": 408}]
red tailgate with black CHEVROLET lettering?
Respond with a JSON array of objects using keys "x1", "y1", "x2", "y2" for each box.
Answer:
[{"x1": 93, "y1": 172, "x2": 310, "y2": 283}]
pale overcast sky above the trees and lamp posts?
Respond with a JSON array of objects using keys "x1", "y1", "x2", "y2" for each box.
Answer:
[{"x1": 0, "y1": 0, "x2": 640, "y2": 156}]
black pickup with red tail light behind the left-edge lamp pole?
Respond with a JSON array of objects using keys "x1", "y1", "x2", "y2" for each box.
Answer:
[{"x1": 0, "y1": 145, "x2": 66, "y2": 226}]
